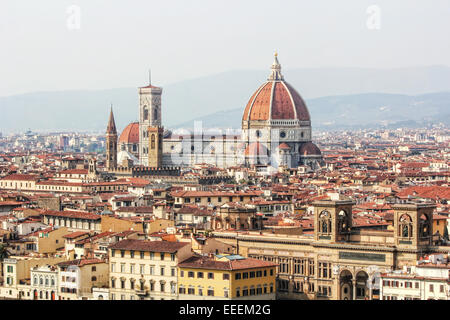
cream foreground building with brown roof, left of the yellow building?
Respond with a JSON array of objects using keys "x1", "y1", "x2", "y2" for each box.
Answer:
[{"x1": 109, "y1": 239, "x2": 192, "y2": 300}]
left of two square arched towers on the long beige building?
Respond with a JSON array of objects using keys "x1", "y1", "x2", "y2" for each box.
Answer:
[{"x1": 313, "y1": 200, "x2": 355, "y2": 242}]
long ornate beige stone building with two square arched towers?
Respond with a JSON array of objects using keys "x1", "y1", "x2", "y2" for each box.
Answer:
[{"x1": 212, "y1": 200, "x2": 448, "y2": 300}]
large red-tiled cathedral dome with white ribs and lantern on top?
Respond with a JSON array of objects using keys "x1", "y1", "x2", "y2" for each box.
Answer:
[{"x1": 242, "y1": 54, "x2": 310, "y2": 121}]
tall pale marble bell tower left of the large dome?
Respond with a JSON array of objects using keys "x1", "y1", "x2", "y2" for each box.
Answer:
[{"x1": 139, "y1": 79, "x2": 162, "y2": 166}]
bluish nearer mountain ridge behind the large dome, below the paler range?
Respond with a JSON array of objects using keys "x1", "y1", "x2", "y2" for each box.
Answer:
[{"x1": 176, "y1": 92, "x2": 450, "y2": 129}]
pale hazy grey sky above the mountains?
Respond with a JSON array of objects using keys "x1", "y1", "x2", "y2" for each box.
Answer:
[{"x1": 0, "y1": 0, "x2": 450, "y2": 96}]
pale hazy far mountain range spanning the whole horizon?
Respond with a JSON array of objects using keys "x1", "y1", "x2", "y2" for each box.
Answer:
[{"x1": 0, "y1": 66, "x2": 450, "y2": 132}]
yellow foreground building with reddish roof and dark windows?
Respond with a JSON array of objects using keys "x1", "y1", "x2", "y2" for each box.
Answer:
[{"x1": 178, "y1": 255, "x2": 277, "y2": 300}]
